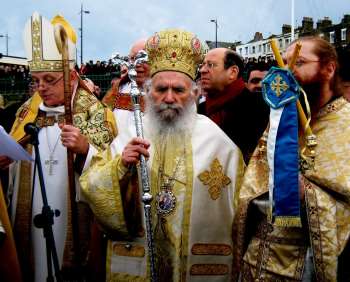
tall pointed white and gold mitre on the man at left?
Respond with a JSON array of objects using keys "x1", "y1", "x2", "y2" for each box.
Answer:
[{"x1": 23, "y1": 12, "x2": 77, "y2": 71}]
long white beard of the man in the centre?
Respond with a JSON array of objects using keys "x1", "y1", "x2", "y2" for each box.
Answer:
[{"x1": 145, "y1": 93, "x2": 197, "y2": 141}]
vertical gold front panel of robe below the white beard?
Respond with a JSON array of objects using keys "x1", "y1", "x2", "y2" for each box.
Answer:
[{"x1": 151, "y1": 133, "x2": 193, "y2": 281}]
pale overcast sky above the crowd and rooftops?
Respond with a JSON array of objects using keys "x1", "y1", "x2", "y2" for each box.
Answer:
[{"x1": 0, "y1": 0, "x2": 350, "y2": 62}]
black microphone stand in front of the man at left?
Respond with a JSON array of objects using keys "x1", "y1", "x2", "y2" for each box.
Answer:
[{"x1": 25, "y1": 124, "x2": 63, "y2": 282}]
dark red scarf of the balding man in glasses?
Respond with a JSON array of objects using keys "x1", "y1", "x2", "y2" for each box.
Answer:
[{"x1": 205, "y1": 78, "x2": 245, "y2": 126}]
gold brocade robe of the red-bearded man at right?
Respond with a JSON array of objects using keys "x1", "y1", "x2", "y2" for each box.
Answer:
[{"x1": 233, "y1": 98, "x2": 350, "y2": 281}]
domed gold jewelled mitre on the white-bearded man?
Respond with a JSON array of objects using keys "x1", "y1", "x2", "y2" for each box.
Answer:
[{"x1": 146, "y1": 29, "x2": 204, "y2": 80}]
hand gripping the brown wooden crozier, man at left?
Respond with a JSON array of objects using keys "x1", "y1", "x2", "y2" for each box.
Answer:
[{"x1": 60, "y1": 124, "x2": 89, "y2": 155}]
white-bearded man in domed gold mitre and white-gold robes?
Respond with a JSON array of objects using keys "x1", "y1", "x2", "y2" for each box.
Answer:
[{"x1": 80, "y1": 29, "x2": 243, "y2": 281}]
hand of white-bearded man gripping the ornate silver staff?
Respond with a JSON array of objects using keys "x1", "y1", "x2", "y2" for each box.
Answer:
[{"x1": 122, "y1": 137, "x2": 150, "y2": 167}]
